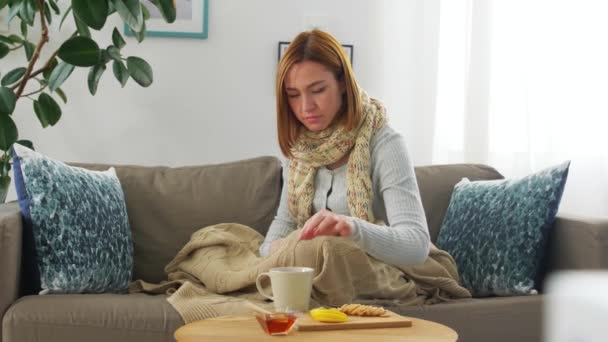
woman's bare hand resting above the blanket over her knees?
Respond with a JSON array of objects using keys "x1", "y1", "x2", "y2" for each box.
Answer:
[{"x1": 300, "y1": 209, "x2": 353, "y2": 240}]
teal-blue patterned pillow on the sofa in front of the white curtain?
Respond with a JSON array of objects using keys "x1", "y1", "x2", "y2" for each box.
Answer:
[{"x1": 437, "y1": 162, "x2": 570, "y2": 297}]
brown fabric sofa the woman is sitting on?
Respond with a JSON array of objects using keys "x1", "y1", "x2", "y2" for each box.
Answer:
[{"x1": 0, "y1": 156, "x2": 608, "y2": 342}]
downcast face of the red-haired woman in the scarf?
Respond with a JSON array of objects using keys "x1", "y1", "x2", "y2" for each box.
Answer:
[{"x1": 284, "y1": 61, "x2": 344, "y2": 132}]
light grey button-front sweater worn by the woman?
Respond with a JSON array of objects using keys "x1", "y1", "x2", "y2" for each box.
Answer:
[{"x1": 260, "y1": 125, "x2": 430, "y2": 267}]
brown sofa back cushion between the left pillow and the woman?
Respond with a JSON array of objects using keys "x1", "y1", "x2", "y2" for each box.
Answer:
[{"x1": 72, "y1": 157, "x2": 281, "y2": 283}]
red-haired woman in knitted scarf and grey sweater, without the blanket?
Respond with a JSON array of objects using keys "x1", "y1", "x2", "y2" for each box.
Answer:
[{"x1": 260, "y1": 30, "x2": 430, "y2": 268}]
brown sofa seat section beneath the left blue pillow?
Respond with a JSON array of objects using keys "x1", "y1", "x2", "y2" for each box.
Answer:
[{"x1": 2, "y1": 294, "x2": 184, "y2": 342}]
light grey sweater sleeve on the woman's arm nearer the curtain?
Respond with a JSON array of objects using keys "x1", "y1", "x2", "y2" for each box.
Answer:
[{"x1": 351, "y1": 127, "x2": 430, "y2": 267}]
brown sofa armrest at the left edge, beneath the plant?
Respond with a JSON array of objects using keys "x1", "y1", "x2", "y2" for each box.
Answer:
[{"x1": 0, "y1": 203, "x2": 23, "y2": 320}]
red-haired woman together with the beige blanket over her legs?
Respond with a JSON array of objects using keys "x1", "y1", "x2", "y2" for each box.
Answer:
[{"x1": 132, "y1": 30, "x2": 471, "y2": 321}]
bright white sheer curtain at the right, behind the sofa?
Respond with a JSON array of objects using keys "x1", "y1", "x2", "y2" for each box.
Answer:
[{"x1": 432, "y1": 0, "x2": 608, "y2": 217}]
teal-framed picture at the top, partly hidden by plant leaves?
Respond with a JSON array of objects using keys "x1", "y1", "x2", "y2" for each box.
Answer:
[{"x1": 124, "y1": 0, "x2": 209, "y2": 39}]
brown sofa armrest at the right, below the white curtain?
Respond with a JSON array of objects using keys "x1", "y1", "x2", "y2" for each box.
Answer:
[{"x1": 548, "y1": 217, "x2": 608, "y2": 272}]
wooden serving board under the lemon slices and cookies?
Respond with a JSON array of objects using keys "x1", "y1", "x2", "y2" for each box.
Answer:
[{"x1": 296, "y1": 310, "x2": 412, "y2": 331}]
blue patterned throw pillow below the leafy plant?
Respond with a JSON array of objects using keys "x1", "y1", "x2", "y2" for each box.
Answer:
[{"x1": 13, "y1": 144, "x2": 133, "y2": 293}]
